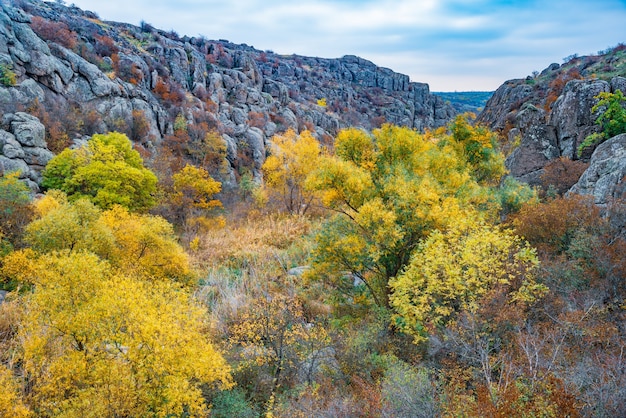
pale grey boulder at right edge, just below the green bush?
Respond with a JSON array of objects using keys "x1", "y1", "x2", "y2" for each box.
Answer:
[{"x1": 568, "y1": 134, "x2": 626, "y2": 205}]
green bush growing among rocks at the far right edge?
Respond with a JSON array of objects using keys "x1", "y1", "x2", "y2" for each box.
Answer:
[{"x1": 577, "y1": 90, "x2": 626, "y2": 157}]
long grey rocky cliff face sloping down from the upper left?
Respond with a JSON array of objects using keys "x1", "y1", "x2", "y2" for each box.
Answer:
[{"x1": 0, "y1": 0, "x2": 456, "y2": 190}]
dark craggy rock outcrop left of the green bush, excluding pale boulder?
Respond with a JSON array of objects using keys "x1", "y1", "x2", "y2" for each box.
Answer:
[{"x1": 477, "y1": 51, "x2": 626, "y2": 185}]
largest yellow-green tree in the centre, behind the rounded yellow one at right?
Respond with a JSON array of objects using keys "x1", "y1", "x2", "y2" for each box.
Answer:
[{"x1": 308, "y1": 118, "x2": 504, "y2": 306}]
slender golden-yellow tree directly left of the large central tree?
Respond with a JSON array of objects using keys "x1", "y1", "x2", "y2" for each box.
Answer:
[{"x1": 262, "y1": 129, "x2": 321, "y2": 215}]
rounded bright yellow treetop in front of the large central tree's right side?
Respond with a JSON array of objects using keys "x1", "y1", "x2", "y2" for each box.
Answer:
[{"x1": 389, "y1": 221, "x2": 547, "y2": 343}]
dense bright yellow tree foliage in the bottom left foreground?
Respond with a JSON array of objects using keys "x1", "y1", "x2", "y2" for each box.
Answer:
[{"x1": 6, "y1": 251, "x2": 231, "y2": 417}]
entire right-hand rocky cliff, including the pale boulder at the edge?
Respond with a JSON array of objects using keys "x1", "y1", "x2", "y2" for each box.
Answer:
[{"x1": 477, "y1": 45, "x2": 626, "y2": 204}]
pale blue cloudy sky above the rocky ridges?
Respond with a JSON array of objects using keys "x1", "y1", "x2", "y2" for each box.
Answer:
[{"x1": 66, "y1": 0, "x2": 626, "y2": 92}]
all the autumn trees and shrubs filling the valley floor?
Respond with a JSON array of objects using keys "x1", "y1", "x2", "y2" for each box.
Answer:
[{"x1": 0, "y1": 108, "x2": 626, "y2": 417}]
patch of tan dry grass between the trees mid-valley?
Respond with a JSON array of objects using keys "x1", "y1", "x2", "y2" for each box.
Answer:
[{"x1": 193, "y1": 214, "x2": 315, "y2": 335}]
